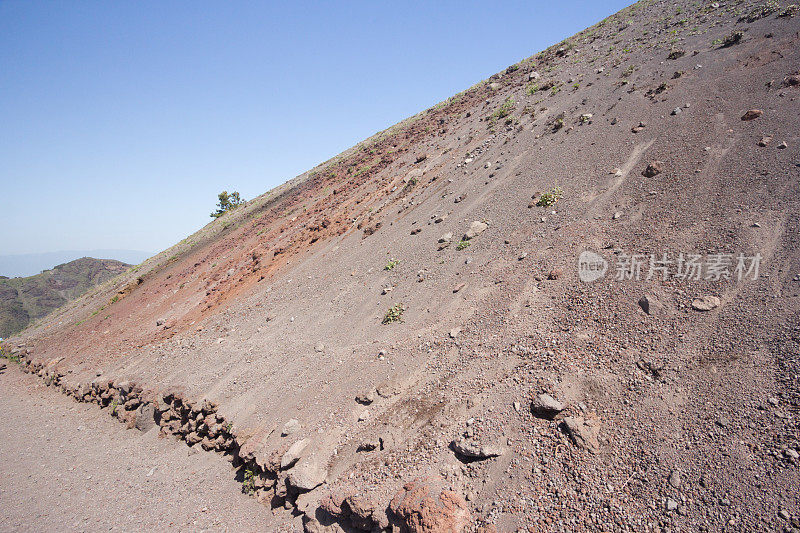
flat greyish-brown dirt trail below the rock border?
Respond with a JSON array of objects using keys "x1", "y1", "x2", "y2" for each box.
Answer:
[{"x1": 0, "y1": 368, "x2": 279, "y2": 531}]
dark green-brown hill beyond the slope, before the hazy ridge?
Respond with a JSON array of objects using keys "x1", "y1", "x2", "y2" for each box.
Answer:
[{"x1": 0, "y1": 257, "x2": 130, "y2": 337}]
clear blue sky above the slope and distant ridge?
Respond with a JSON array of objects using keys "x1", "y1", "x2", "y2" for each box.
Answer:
[{"x1": 0, "y1": 0, "x2": 631, "y2": 255}]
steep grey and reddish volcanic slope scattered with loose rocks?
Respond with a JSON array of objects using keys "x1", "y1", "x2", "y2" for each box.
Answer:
[{"x1": 6, "y1": 1, "x2": 800, "y2": 531}]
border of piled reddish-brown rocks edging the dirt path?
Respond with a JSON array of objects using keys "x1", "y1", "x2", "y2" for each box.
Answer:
[{"x1": 4, "y1": 348, "x2": 470, "y2": 532}]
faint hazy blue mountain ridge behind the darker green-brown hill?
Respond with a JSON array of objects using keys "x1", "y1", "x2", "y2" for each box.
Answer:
[{"x1": 0, "y1": 249, "x2": 152, "y2": 278}]
